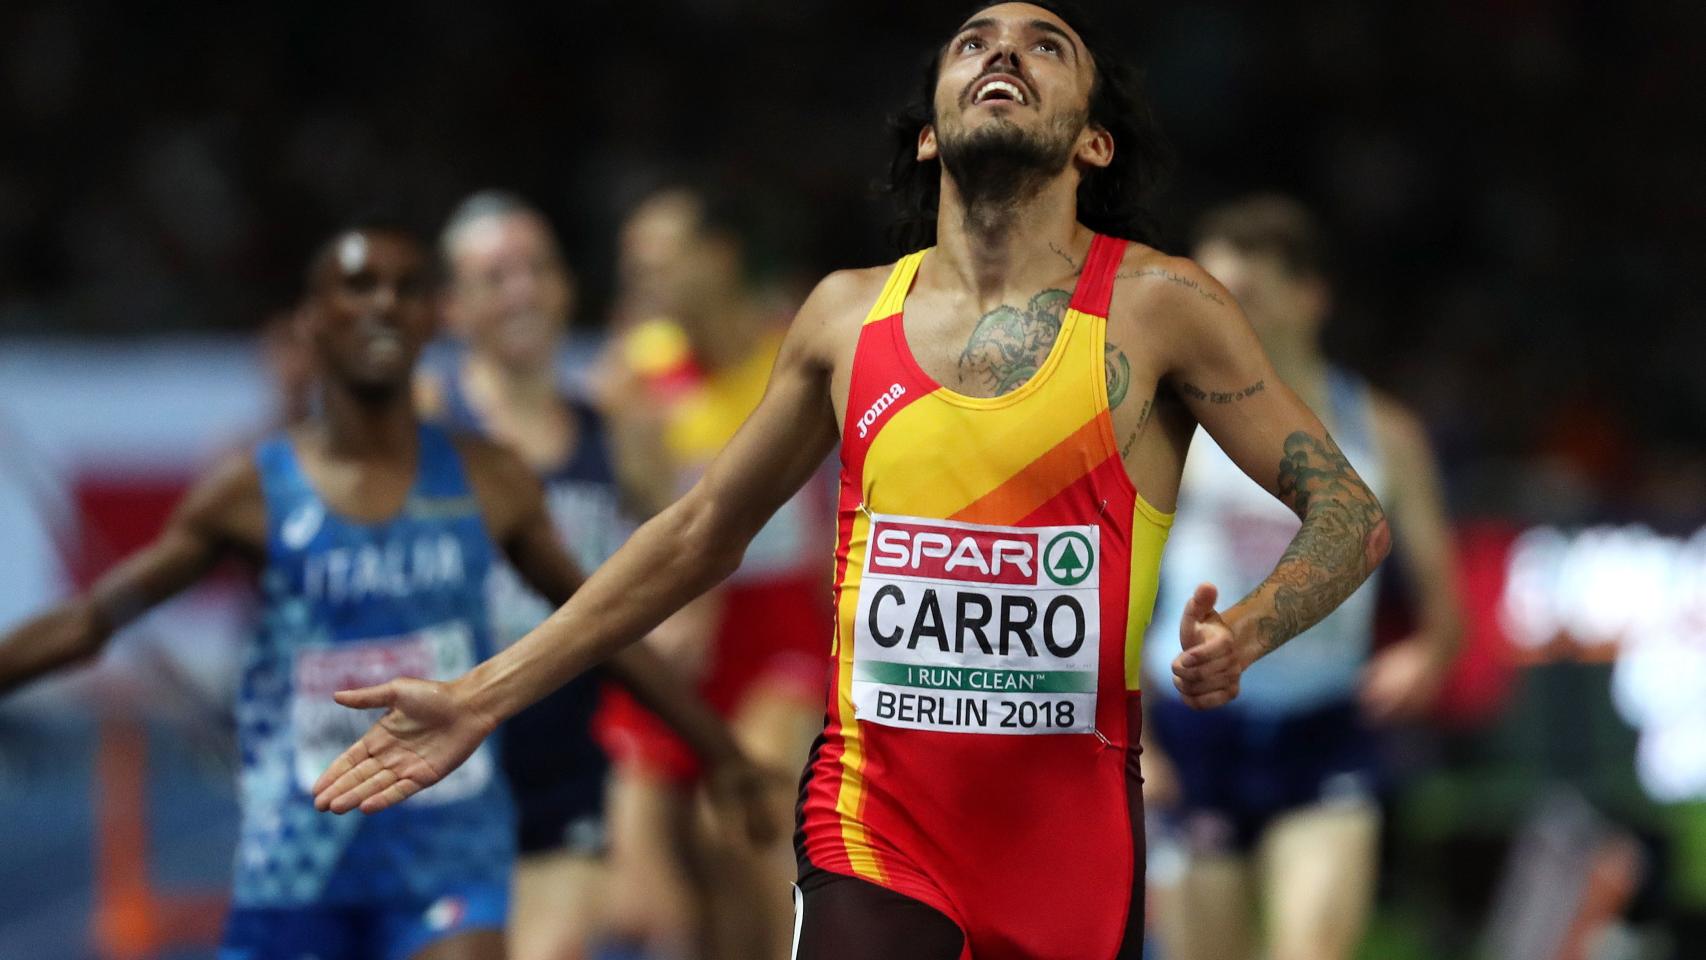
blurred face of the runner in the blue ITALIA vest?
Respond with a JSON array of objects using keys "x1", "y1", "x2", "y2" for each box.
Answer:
[{"x1": 307, "y1": 230, "x2": 432, "y2": 390}]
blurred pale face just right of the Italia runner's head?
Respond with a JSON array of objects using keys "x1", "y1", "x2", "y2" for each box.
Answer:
[{"x1": 445, "y1": 213, "x2": 573, "y2": 368}]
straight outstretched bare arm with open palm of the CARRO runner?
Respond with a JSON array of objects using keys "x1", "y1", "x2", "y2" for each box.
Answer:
[{"x1": 316, "y1": 274, "x2": 853, "y2": 812}]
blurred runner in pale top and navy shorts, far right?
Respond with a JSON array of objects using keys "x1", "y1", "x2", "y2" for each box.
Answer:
[{"x1": 1145, "y1": 196, "x2": 1462, "y2": 960}]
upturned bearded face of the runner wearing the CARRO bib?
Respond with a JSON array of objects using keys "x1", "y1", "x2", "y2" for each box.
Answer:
[{"x1": 921, "y1": 3, "x2": 1095, "y2": 159}]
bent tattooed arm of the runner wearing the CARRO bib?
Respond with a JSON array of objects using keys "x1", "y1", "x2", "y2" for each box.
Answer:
[{"x1": 1148, "y1": 261, "x2": 1390, "y2": 708}]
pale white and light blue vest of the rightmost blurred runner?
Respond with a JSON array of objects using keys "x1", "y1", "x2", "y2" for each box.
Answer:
[{"x1": 1143, "y1": 368, "x2": 1385, "y2": 716}]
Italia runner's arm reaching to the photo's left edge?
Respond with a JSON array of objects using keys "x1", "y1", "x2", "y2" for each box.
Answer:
[{"x1": 0, "y1": 457, "x2": 264, "y2": 696}]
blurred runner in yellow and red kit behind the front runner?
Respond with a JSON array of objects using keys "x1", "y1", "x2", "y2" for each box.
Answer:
[{"x1": 601, "y1": 188, "x2": 833, "y2": 960}]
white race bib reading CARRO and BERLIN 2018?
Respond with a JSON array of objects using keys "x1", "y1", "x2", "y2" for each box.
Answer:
[{"x1": 853, "y1": 513, "x2": 1102, "y2": 735}]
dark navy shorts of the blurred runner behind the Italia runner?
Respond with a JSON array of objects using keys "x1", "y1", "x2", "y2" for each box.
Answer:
[{"x1": 502, "y1": 677, "x2": 611, "y2": 856}]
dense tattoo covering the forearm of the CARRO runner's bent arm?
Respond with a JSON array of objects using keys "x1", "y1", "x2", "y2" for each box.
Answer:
[{"x1": 1249, "y1": 430, "x2": 1389, "y2": 651}]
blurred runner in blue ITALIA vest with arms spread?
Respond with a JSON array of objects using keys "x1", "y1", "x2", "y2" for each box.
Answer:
[{"x1": 0, "y1": 225, "x2": 763, "y2": 960}]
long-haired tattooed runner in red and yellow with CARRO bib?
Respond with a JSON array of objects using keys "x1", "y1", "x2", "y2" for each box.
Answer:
[{"x1": 316, "y1": 2, "x2": 1387, "y2": 960}]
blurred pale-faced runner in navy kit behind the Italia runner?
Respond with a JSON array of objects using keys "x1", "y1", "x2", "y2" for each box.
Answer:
[{"x1": 416, "y1": 191, "x2": 644, "y2": 960}]
